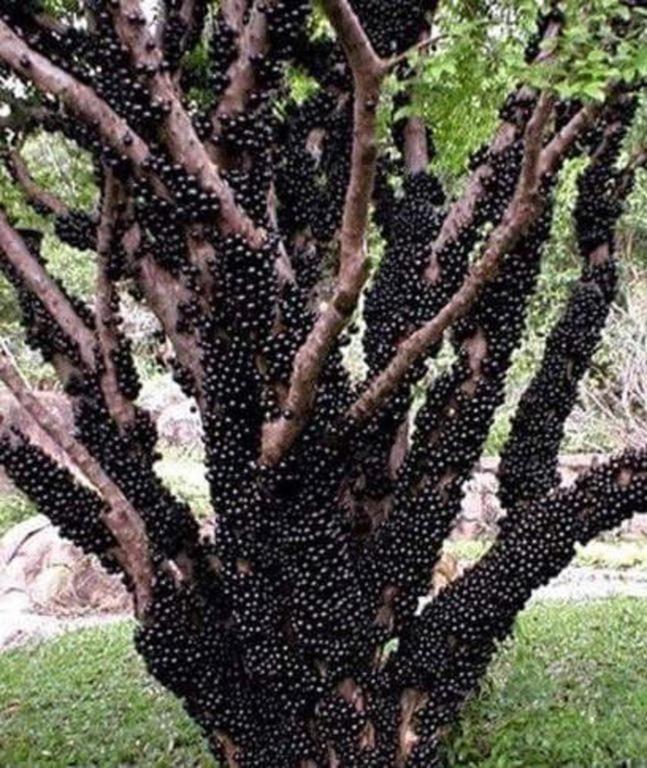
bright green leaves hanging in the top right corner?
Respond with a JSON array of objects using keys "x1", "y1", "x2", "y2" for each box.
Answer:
[{"x1": 383, "y1": 0, "x2": 647, "y2": 181}]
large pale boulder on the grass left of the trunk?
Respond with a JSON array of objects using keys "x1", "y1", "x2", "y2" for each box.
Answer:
[{"x1": 0, "y1": 515, "x2": 132, "y2": 616}]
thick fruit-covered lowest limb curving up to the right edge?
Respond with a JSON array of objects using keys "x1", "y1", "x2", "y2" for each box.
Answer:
[{"x1": 389, "y1": 450, "x2": 647, "y2": 765}]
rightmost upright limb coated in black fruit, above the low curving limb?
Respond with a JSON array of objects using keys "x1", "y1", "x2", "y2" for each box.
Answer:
[{"x1": 498, "y1": 105, "x2": 631, "y2": 516}]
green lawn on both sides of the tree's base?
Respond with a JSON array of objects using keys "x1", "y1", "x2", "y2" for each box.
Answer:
[{"x1": 0, "y1": 599, "x2": 647, "y2": 768}]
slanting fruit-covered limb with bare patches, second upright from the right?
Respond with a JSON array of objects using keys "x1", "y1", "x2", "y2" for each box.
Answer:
[{"x1": 363, "y1": 214, "x2": 549, "y2": 634}]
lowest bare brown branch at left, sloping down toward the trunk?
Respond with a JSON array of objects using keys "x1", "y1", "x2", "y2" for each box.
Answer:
[{"x1": 0, "y1": 348, "x2": 153, "y2": 617}]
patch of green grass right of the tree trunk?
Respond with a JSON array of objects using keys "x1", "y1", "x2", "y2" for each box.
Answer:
[{"x1": 448, "y1": 599, "x2": 647, "y2": 768}]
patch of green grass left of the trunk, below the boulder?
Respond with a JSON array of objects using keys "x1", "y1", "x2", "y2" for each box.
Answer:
[{"x1": 0, "y1": 624, "x2": 213, "y2": 768}]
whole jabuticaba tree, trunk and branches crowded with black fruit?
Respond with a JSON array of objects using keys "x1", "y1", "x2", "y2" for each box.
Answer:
[{"x1": 0, "y1": 0, "x2": 647, "y2": 768}]
